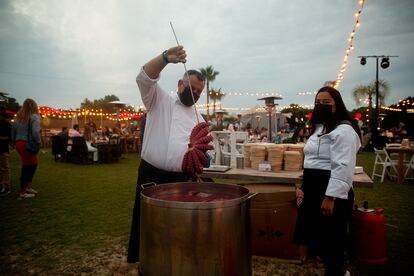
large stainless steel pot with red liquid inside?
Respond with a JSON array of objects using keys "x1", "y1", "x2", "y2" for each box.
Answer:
[{"x1": 140, "y1": 182, "x2": 251, "y2": 276}]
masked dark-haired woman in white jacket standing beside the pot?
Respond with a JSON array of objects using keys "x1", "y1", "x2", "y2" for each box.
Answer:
[{"x1": 294, "y1": 87, "x2": 361, "y2": 275}]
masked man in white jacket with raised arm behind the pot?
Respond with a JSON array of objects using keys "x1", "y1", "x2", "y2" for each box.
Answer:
[{"x1": 127, "y1": 46, "x2": 205, "y2": 263}]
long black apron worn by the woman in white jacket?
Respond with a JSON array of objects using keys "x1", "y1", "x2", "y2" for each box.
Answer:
[{"x1": 293, "y1": 169, "x2": 354, "y2": 275}]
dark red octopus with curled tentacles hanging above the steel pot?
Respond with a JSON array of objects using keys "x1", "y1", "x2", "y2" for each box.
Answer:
[{"x1": 181, "y1": 122, "x2": 214, "y2": 175}]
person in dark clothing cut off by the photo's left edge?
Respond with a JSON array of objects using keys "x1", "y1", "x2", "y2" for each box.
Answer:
[{"x1": 0, "y1": 106, "x2": 12, "y2": 195}]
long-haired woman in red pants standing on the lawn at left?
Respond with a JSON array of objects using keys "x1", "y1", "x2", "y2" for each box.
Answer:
[{"x1": 12, "y1": 99, "x2": 40, "y2": 198}]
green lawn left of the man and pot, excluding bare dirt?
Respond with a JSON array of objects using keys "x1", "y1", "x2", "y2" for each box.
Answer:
[{"x1": 0, "y1": 150, "x2": 139, "y2": 275}]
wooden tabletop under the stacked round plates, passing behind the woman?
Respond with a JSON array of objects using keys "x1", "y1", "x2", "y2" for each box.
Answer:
[{"x1": 201, "y1": 168, "x2": 373, "y2": 188}]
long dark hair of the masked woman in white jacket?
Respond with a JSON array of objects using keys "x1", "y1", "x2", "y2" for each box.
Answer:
[{"x1": 310, "y1": 86, "x2": 361, "y2": 137}]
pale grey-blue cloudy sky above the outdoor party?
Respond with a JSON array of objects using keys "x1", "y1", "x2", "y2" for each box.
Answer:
[{"x1": 0, "y1": 0, "x2": 414, "y2": 112}]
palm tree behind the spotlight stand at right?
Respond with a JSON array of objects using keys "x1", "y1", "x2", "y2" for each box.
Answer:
[{"x1": 352, "y1": 80, "x2": 389, "y2": 123}]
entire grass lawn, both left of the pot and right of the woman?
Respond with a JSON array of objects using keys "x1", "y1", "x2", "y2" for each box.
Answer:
[{"x1": 0, "y1": 150, "x2": 414, "y2": 275}]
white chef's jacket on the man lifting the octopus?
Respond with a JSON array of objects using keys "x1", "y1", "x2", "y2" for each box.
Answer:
[{"x1": 136, "y1": 68, "x2": 204, "y2": 172}]
